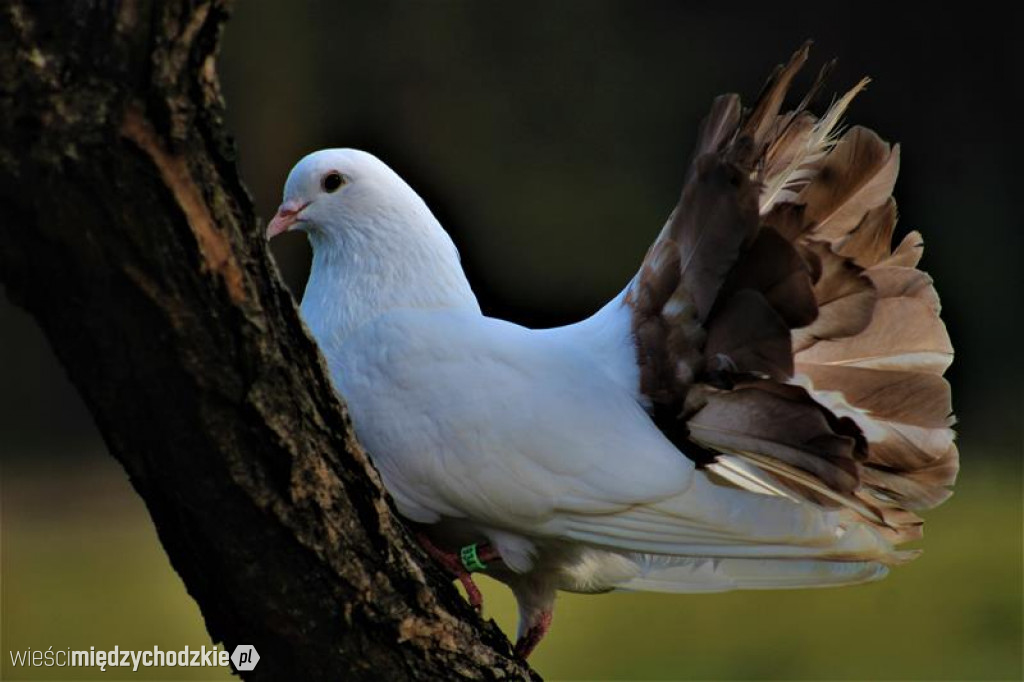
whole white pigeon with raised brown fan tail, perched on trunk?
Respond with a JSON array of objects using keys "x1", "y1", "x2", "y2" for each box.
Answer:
[{"x1": 266, "y1": 46, "x2": 958, "y2": 657}]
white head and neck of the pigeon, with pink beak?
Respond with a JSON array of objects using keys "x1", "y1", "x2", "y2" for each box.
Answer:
[{"x1": 266, "y1": 150, "x2": 479, "y2": 335}]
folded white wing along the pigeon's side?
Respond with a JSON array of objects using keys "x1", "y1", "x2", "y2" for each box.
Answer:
[{"x1": 328, "y1": 310, "x2": 872, "y2": 557}]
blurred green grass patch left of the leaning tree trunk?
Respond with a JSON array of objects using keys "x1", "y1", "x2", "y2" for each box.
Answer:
[{"x1": 0, "y1": 457, "x2": 234, "y2": 680}]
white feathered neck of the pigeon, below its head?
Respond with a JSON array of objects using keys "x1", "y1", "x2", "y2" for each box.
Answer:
[{"x1": 302, "y1": 207, "x2": 480, "y2": 345}]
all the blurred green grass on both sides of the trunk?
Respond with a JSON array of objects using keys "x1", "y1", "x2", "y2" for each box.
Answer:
[{"x1": 0, "y1": 458, "x2": 1022, "y2": 680}]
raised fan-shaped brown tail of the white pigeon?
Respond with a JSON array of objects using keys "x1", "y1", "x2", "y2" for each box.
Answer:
[{"x1": 627, "y1": 46, "x2": 957, "y2": 542}]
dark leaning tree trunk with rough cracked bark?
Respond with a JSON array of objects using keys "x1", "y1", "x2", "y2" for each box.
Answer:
[{"x1": 0, "y1": 0, "x2": 531, "y2": 680}]
